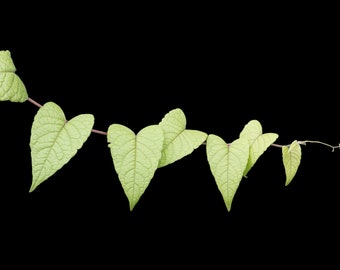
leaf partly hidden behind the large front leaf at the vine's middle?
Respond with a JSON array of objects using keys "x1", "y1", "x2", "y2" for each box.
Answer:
[{"x1": 158, "y1": 109, "x2": 208, "y2": 167}]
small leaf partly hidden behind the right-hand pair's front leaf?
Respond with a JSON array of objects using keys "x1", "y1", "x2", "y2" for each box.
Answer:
[{"x1": 240, "y1": 120, "x2": 279, "y2": 177}]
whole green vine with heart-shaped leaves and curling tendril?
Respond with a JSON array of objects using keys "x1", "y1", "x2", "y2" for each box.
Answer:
[{"x1": 0, "y1": 50, "x2": 340, "y2": 211}]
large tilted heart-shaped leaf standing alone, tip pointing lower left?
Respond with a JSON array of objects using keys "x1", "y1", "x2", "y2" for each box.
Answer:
[{"x1": 30, "y1": 102, "x2": 94, "y2": 192}]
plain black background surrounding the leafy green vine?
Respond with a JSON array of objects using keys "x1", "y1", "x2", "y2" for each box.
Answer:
[{"x1": 0, "y1": 2, "x2": 340, "y2": 267}]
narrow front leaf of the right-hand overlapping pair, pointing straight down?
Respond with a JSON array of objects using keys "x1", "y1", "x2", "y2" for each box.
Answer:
[{"x1": 206, "y1": 134, "x2": 249, "y2": 211}]
